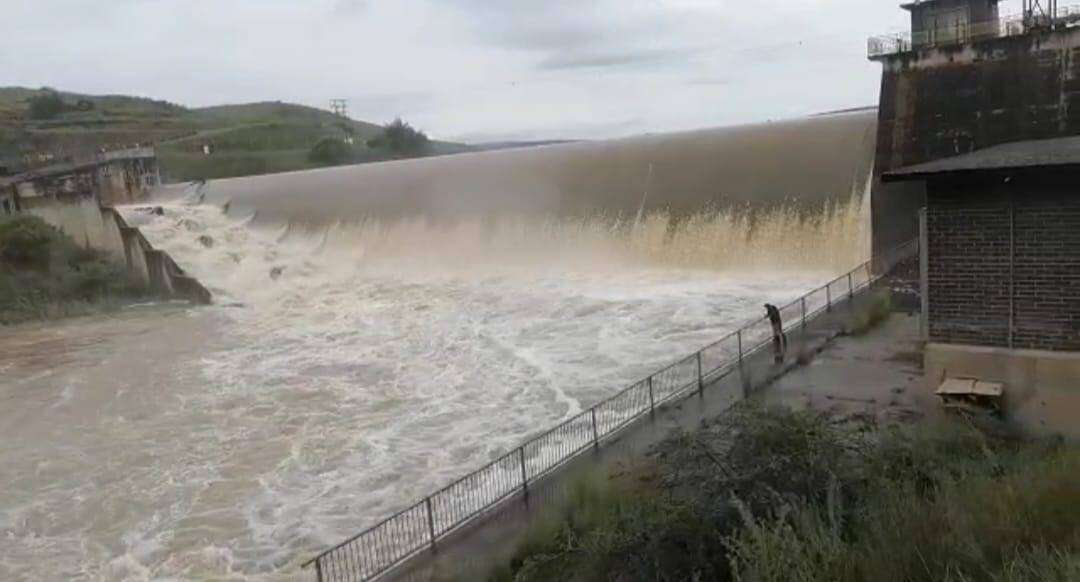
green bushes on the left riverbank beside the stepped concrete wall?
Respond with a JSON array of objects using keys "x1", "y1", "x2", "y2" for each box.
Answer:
[{"x1": 0, "y1": 215, "x2": 143, "y2": 324}]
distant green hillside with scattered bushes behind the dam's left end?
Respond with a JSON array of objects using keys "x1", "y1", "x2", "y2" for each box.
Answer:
[{"x1": 0, "y1": 87, "x2": 473, "y2": 180}]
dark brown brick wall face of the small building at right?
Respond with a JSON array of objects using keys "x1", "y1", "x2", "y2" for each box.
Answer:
[{"x1": 927, "y1": 178, "x2": 1080, "y2": 350}]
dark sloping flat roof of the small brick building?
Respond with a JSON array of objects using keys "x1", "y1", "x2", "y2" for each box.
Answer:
[{"x1": 881, "y1": 136, "x2": 1080, "y2": 181}]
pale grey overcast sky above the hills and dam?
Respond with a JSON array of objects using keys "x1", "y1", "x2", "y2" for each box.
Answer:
[{"x1": 0, "y1": 0, "x2": 1002, "y2": 141}]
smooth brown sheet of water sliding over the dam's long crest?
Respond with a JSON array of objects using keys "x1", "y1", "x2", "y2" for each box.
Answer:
[{"x1": 198, "y1": 110, "x2": 876, "y2": 225}]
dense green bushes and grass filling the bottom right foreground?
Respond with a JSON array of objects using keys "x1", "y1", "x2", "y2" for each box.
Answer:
[{"x1": 489, "y1": 405, "x2": 1080, "y2": 582}]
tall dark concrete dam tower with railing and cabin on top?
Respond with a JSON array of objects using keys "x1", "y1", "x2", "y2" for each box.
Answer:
[{"x1": 868, "y1": 0, "x2": 1080, "y2": 253}]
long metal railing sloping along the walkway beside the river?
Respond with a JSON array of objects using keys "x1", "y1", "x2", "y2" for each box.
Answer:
[{"x1": 303, "y1": 241, "x2": 918, "y2": 582}]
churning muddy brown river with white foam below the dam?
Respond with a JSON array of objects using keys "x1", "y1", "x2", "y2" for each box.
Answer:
[{"x1": 0, "y1": 111, "x2": 867, "y2": 580}]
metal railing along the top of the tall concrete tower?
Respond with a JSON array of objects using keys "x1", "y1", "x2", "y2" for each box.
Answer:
[{"x1": 866, "y1": 5, "x2": 1080, "y2": 58}]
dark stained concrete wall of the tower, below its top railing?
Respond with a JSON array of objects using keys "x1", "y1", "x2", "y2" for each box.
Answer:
[{"x1": 872, "y1": 28, "x2": 1080, "y2": 253}]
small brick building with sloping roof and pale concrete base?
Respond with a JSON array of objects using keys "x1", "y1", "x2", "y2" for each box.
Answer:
[{"x1": 881, "y1": 137, "x2": 1080, "y2": 436}]
